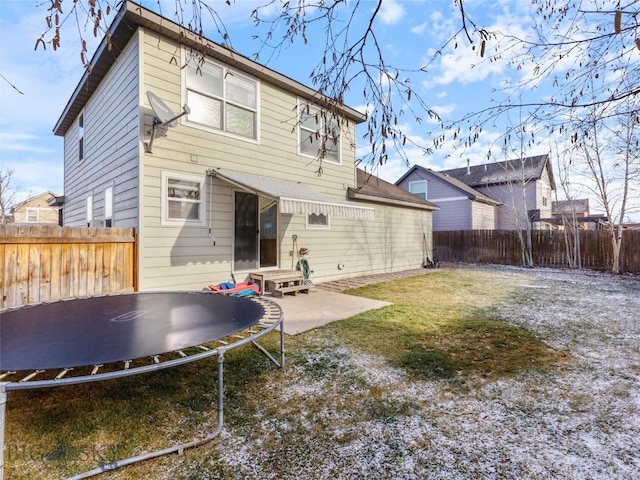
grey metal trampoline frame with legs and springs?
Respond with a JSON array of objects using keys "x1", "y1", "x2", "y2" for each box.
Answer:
[{"x1": 0, "y1": 292, "x2": 285, "y2": 480}]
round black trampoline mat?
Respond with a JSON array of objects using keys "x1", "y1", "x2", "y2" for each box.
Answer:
[{"x1": 0, "y1": 292, "x2": 264, "y2": 371}]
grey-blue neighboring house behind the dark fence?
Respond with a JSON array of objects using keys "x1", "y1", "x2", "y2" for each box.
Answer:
[{"x1": 396, "y1": 155, "x2": 555, "y2": 231}]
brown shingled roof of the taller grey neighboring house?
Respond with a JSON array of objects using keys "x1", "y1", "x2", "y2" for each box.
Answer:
[{"x1": 440, "y1": 154, "x2": 556, "y2": 190}]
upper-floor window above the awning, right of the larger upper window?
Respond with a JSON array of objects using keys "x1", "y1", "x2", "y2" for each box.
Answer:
[{"x1": 298, "y1": 102, "x2": 341, "y2": 163}]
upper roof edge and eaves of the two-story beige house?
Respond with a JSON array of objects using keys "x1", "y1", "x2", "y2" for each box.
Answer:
[{"x1": 53, "y1": 0, "x2": 366, "y2": 135}]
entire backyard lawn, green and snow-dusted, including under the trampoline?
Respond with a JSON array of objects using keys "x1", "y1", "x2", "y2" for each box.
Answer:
[{"x1": 5, "y1": 268, "x2": 640, "y2": 480}]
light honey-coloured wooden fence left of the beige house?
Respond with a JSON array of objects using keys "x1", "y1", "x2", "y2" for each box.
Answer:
[{"x1": 0, "y1": 225, "x2": 136, "y2": 308}]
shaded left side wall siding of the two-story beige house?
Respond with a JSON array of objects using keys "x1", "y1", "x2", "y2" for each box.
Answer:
[{"x1": 64, "y1": 36, "x2": 139, "y2": 227}]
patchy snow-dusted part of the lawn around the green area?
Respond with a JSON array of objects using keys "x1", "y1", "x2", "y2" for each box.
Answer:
[{"x1": 173, "y1": 269, "x2": 640, "y2": 479}]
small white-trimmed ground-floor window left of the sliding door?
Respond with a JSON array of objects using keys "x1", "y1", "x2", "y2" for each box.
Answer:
[{"x1": 162, "y1": 172, "x2": 206, "y2": 225}]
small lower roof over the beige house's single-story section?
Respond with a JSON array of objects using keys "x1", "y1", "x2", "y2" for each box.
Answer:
[{"x1": 347, "y1": 168, "x2": 440, "y2": 210}]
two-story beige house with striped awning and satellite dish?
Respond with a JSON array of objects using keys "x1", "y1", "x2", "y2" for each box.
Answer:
[{"x1": 54, "y1": 1, "x2": 437, "y2": 290}]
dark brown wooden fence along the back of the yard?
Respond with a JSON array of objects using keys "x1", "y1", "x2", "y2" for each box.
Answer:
[{"x1": 433, "y1": 230, "x2": 640, "y2": 273}]
